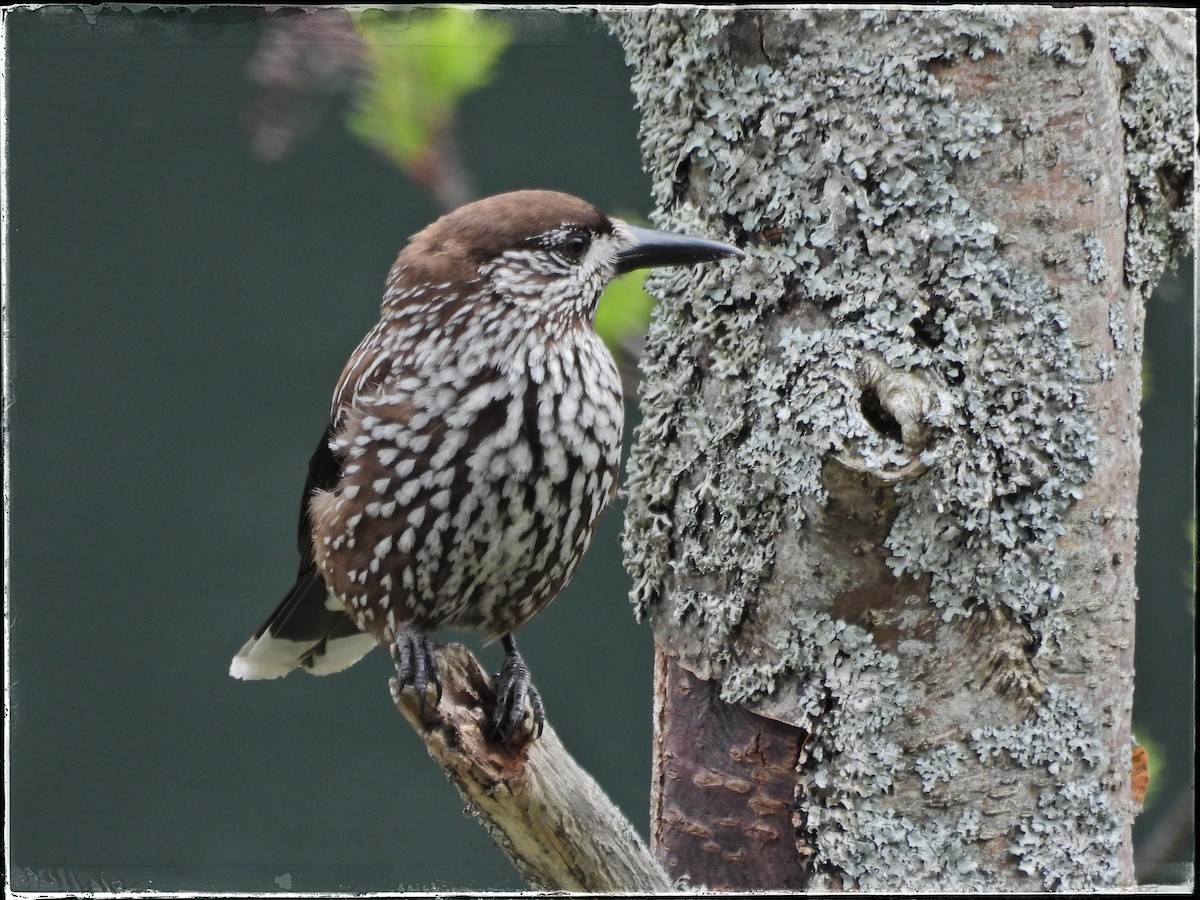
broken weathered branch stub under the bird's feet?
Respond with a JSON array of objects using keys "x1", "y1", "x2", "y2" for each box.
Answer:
[{"x1": 391, "y1": 644, "x2": 671, "y2": 893}]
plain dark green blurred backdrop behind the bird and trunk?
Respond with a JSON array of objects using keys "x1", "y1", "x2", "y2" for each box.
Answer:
[{"x1": 5, "y1": 7, "x2": 1193, "y2": 890}]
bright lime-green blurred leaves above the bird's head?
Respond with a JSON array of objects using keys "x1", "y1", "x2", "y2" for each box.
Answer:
[{"x1": 348, "y1": 8, "x2": 514, "y2": 169}]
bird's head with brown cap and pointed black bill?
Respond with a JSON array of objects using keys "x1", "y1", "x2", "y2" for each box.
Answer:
[{"x1": 384, "y1": 191, "x2": 744, "y2": 322}]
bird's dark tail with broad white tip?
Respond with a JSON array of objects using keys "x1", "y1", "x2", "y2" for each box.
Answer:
[{"x1": 229, "y1": 569, "x2": 376, "y2": 680}]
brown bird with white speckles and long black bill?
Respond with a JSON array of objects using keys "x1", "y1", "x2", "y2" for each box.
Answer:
[{"x1": 229, "y1": 190, "x2": 745, "y2": 742}]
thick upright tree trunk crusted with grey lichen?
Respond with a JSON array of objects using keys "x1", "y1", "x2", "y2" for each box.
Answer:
[{"x1": 610, "y1": 7, "x2": 1195, "y2": 890}]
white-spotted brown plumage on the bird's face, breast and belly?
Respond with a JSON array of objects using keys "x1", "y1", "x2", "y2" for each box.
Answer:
[{"x1": 311, "y1": 199, "x2": 630, "y2": 642}]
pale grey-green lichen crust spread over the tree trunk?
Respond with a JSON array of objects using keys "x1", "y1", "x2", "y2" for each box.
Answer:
[{"x1": 612, "y1": 8, "x2": 1174, "y2": 889}]
